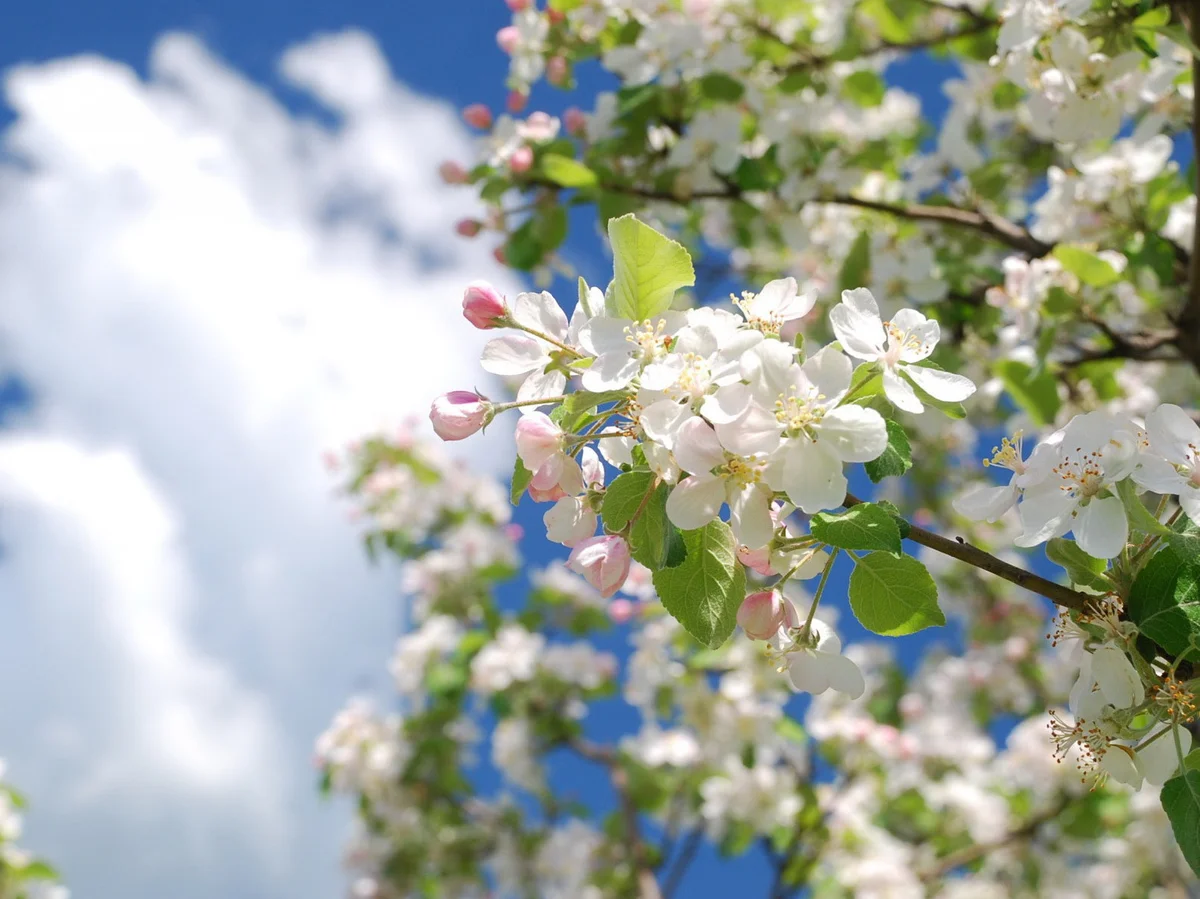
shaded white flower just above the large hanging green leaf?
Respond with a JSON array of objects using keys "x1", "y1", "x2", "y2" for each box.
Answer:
[{"x1": 667, "y1": 418, "x2": 774, "y2": 549}]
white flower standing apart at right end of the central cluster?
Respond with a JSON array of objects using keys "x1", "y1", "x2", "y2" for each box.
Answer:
[{"x1": 829, "y1": 287, "x2": 976, "y2": 412}]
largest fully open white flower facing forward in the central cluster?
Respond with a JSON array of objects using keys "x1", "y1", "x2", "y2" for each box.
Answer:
[{"x1": 706, "y1": 340, "x2": 888, "y2": 513}]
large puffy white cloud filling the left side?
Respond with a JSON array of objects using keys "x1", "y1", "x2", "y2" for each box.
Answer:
[{"x1": 0, "y1": 32, "x2": 517, "y2": 899}]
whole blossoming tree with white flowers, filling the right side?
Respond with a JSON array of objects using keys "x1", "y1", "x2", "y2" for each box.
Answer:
[{"x1": 319, "y1": 0, "x2": 1200, "y2": 899}]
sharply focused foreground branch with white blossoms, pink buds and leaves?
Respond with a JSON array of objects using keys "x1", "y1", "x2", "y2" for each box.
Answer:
[{"x1": 431, "y1": 216, "x2": 1200, "y2": 865}]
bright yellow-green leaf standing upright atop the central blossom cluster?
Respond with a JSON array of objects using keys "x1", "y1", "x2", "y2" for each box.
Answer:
[{"x1": 608, "y1": 215, "x2": 696, "y2": 322}]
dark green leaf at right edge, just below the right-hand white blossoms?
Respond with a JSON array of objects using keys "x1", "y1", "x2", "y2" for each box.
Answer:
[{"x1": 1128, "y1": 546, "x2": 1200, "y2": 657}]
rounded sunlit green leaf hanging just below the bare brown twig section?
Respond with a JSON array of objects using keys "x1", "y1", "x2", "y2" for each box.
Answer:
[{"x1": 850, "y1": 552, "x2": 946, "y2": 637}]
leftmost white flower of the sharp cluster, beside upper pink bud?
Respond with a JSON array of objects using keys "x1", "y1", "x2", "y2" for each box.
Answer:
[{"x1": 480, "y1": 290, "x2": 568, "y2": 413}]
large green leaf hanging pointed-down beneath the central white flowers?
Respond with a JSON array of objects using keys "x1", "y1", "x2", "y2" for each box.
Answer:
[{"x1": 654, "y1": 521, "x2": 746, "y2": 649}]
